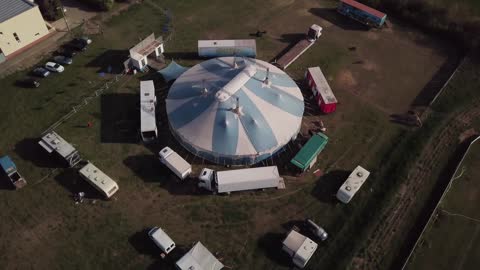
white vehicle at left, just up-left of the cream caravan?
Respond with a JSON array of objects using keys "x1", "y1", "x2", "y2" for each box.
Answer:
[{"x1": 38, "y1": 131, "x2": 81, "y2": 167}]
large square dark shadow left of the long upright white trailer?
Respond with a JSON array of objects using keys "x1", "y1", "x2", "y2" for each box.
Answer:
[{"x1": 100, "y1": 93, "x2": 140, "y2": 143}]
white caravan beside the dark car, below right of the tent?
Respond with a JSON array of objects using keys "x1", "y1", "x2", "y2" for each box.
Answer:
[{"x1": 282, "y1": 230, "x2": 318, "y2": 268}]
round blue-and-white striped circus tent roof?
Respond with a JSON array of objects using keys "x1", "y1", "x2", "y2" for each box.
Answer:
[{"x1": 166, "y1": 57, "x2": 304, "y2": 163}]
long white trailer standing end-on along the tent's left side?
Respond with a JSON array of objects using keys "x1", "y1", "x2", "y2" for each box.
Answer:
[{"x1": 140, "y1": 80, "x2": 158, "y2": 142}]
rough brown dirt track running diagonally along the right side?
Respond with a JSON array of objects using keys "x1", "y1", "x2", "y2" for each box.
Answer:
[{"x1": 351, "y1": 97, "x2": 480, "y2": 270}]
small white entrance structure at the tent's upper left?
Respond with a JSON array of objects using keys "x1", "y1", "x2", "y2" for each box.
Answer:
[{"x1": 126, "y1": 33, "x2": 164, "y2": 70}]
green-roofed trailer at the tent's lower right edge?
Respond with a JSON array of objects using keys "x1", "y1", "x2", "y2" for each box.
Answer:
[{"x1": 290, "y1": 133, "x2": 328, "y2": 171}]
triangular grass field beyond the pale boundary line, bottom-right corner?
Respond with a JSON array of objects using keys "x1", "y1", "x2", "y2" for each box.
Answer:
[{"x1": 406, "y1": 140, "x2": 480, "y2": 269}]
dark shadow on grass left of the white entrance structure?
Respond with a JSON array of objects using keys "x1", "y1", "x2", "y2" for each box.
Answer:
[{"x1": 86, "y1": 50, "x2": 130, "y2": 74}]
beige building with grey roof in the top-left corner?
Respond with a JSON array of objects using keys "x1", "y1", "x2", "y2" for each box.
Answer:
[{"x1": 0, "y1": 0, "x2": 48, "y2": 62}]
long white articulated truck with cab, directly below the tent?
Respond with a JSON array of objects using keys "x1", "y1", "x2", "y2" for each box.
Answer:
[{"x1": 198, "y1": 166, "x2": 285, "y2": 194}]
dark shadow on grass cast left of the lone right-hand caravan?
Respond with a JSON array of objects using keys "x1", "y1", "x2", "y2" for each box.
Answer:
[{"x1": 312, "y1": 170, "x2": 351, "y2": 203}]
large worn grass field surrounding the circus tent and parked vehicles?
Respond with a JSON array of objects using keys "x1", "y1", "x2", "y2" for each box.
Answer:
[{"x1": 0, "y1": 0, "x2": 464, "y2": 269}]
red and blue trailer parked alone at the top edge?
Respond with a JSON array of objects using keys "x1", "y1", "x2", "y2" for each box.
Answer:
[{"x1": 337, "y1": 0, "x2": 387, "y2": 28}]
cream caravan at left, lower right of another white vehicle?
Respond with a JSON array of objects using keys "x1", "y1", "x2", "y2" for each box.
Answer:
[{"x1": 78, "y1": 162, "x2": 118, "y2": 199}]
